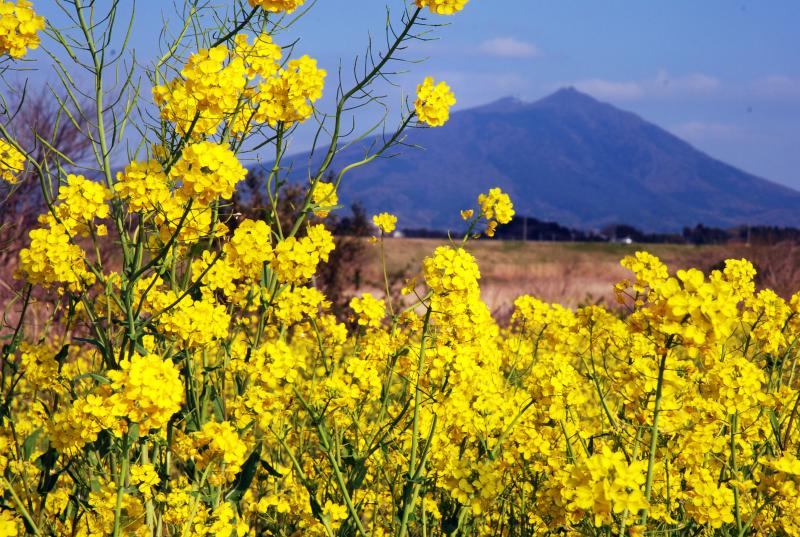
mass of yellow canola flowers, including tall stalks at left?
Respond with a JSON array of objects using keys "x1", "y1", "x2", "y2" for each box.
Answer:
[{"x1": 0, "y1": 0, "x2": 800, "y2": 537}]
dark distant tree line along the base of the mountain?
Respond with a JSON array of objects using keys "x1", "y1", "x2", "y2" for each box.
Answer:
[{"x1": 402, "y1": 216, "x2": 800, "y2": 244}]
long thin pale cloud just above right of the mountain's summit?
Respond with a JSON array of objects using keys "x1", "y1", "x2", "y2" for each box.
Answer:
[{"x1": 562, "y1": 69, "x2": 721, "y2": 101}]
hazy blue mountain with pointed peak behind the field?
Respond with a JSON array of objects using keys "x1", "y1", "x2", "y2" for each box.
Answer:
[{"x1": 280, "y1": 88, "x2": 800, "y2": 231}]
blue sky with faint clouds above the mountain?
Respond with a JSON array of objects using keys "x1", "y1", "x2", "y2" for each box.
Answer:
[{"x1": 36, "y1": 0, "x2": 800, "y2": 189}]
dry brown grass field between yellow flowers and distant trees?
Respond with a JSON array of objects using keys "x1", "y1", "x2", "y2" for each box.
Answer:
[{"x1": 362, "y1": 238, "x2": 800, "y2": 313}]
